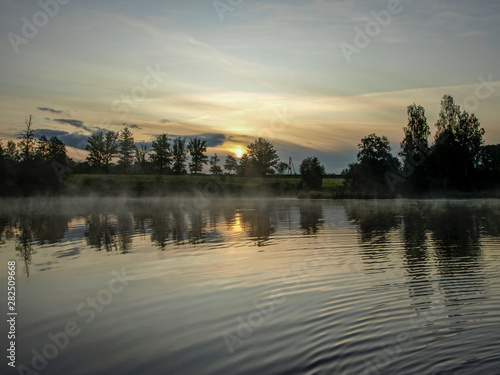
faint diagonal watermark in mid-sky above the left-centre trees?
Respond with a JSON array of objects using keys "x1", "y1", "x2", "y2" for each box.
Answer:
[{"x1": 111, "y1": 64, "x2": 168, "y2": 120}]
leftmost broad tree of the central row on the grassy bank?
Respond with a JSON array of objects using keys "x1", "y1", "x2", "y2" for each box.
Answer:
[{"x1": 85, "y1": 130, "x2": 118, "y2": 173}]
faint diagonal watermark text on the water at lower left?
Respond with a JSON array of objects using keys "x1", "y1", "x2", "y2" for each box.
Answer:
[{"x1": 17, "y1": 268, "x2": 132, "y2": 375}]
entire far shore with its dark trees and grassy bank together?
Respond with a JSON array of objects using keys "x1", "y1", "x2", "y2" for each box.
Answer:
[{"x1": 0, "y1": 95, "x2": 500, "y2": 200}]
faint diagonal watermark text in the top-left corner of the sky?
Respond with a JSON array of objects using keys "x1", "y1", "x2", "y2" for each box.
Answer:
[{"x1": 7, "y1": 0, "x2": 70, "y2": 55}]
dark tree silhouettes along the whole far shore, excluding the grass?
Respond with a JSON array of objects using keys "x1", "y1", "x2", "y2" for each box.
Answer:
[{"x1": 0, "y1": 95, "x2": 500, "y2": 197}]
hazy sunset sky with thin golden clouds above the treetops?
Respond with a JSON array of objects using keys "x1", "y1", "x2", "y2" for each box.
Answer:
[{"x1": 0, "y1": 0, "x2": 500, "y2": 172}]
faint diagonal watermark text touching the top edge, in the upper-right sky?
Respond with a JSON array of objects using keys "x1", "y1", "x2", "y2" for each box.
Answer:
[{"x1": 339, "y1": 0, "x2": 412, "y2": 63}]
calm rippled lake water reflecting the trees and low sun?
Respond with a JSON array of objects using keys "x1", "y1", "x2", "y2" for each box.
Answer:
[{"x1": 0, "y1": 198, "x2": 500, "y2": 374}]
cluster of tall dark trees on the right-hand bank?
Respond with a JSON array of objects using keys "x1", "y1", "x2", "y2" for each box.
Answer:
[{"x1": 343, "y1": 95, "x2": 500, "y2": 196}]
